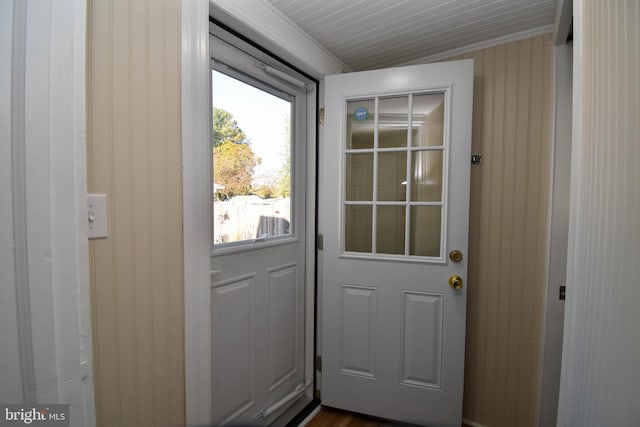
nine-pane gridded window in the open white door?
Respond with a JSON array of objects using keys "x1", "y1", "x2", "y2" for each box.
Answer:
[{"x1": 344, "y1": 93, "x2": 445, "y2": 258}]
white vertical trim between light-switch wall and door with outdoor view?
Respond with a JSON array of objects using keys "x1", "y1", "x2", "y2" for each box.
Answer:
[{"x1": 181, "y1": 0, "x2": 212, "y2": 426}]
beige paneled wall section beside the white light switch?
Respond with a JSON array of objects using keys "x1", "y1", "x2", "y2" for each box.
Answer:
[{"x1": 88, "y1": 0, "x2": 185, "y2": 427}]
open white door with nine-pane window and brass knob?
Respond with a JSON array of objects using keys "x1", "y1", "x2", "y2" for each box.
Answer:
[{"x1": 320, "y1": 60, "x2": 473, "y2": 427}]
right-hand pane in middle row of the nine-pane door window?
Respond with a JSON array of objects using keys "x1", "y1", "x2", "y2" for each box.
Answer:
[{"x1": 411, "y1": 151, "x2": 443, "y2": 202}]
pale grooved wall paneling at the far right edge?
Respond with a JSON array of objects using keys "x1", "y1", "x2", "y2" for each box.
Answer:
[{"x1": 558, "y1": 0, "x2": 640, "y2": 427}]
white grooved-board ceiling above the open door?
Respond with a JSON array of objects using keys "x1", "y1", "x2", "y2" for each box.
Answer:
[{"x1": 268, "y1": 0, "x2": 557, "y2": 71}]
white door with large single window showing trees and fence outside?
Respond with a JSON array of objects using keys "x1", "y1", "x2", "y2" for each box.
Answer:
[{"x1": 210, "y1": 28, "x2": 307, "y2": 425}]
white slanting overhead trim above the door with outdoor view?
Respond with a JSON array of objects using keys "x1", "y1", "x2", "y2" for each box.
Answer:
[{"x1": 212, "y1": 0, "x2": 351, "y2": 78}]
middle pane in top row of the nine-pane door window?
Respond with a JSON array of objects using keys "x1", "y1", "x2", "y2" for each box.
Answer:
[{"x1": 378, "y1": 96, "x2": 409, "y2": 148}]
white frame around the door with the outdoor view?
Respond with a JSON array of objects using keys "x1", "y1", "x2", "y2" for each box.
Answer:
[{"x1": 181, "y1": 0, "x2": 344, "y2": 425}]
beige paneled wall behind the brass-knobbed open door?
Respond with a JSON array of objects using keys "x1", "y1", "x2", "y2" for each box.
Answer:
[{"x1": 444, "y1": 35, "x2": 552, "y2": 427}]
